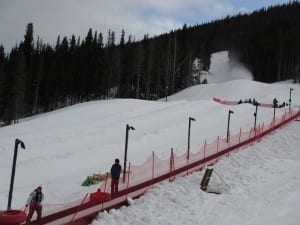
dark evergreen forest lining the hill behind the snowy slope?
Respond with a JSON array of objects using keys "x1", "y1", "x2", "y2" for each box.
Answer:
[{"x1": 0, "y1": 1, "x2": 300, "y2": 124}]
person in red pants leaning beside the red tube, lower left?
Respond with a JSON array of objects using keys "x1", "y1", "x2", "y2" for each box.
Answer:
[{"x1": 26, "y1": 186, "x2": 44, "y2": 225}]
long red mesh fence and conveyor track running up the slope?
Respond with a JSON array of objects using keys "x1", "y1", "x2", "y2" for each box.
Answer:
[{"x1": 27, "y1": 110, "x2": 300, "y2": 225}]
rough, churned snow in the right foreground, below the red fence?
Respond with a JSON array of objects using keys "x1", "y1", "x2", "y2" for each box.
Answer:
[{"x1": 92, "y1": 122, "x2": 300, "y2": 225}]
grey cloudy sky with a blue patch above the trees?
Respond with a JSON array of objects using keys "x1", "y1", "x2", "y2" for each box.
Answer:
[{"x1": 0, "y1": 0, "x2": 289, "y2": 50}]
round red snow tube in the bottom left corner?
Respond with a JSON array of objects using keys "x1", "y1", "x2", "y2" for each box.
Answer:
[{"x1": 0, "y1": 210, "x2": 27, "y2": 225}]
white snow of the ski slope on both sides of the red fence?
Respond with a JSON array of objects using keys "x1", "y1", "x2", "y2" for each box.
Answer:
[{"x1": 0, "y1": 52, "x2": 300, "y2": 225}]
